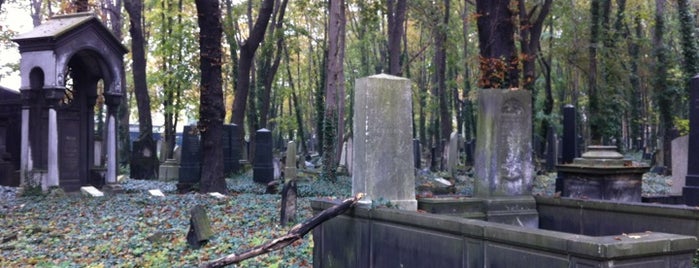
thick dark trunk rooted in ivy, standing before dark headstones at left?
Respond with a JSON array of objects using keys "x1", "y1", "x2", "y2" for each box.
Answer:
[{"x1": 195, "y1": 0, "x2": 228, "y2": 194}]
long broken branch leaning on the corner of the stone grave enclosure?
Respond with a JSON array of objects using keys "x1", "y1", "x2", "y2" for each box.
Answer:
[{"x1": 202, "y1": 193, "x2": 364, "y2": 268}]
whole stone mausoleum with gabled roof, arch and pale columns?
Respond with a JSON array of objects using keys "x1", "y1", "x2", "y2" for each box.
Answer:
[{"x1": 13, "y1": 13, "x2": 127, "y2": 191}]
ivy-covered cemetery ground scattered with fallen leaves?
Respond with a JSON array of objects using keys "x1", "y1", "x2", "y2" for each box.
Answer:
[{"x1": 0, "y1": 162, "x2": 669, "y2": 267}]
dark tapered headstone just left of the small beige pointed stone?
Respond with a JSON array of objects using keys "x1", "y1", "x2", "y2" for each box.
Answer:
[{"x1": 252, "y1": 128, "x2": 274, "y2": 184}]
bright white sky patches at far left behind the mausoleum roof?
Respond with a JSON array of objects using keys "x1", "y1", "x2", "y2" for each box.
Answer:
[{"x1": 0, "y1": 1, "x2": 33, "y2": 90}]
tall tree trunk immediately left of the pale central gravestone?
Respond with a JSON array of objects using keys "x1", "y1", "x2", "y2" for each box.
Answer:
[{"x1": 323, "y1": 0, "x2": 346, "y2": 181}]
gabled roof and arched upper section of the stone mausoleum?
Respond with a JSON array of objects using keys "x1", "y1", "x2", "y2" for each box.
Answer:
[{"x1": 12, "y1": 12, "x2": 128, "y2": 95}]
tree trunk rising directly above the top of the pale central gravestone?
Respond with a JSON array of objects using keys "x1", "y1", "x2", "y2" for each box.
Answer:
[{"x1": 386, "y1": 0, "x2": 407, "y2": 76}]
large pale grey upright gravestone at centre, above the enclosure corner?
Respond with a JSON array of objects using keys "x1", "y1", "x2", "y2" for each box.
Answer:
[{"x1": 352, "y1": 74, "x2": 417, "y2": 211}]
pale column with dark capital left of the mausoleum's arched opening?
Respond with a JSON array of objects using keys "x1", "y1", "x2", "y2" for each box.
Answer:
[{"x1": 42, "y1": 87, "x2": 65, "y2": 190}]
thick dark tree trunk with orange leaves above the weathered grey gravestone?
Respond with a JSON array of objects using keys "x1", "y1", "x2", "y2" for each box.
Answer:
[{"x1": 476, "y1": 0, "x2": 519, "y2": 88}]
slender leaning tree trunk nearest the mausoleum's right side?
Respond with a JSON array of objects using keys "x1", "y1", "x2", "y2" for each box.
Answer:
[{"x1": 124, "y1": 0, "x2": 158, "y2": 179}]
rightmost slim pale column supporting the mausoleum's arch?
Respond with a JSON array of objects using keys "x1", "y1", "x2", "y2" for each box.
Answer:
[{"x1": 104, "y1": 93, "x2": 121, "y2": 187}]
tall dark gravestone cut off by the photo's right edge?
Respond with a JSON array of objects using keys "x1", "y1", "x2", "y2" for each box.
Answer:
[{"x1": 682, "y1": 75, "x2": 699, "y2": 206}]
